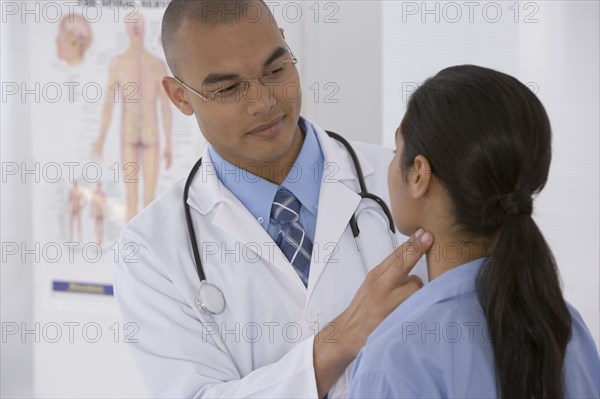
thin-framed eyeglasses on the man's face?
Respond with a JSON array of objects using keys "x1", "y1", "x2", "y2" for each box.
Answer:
[{"x1": 174, "y1": 48, "x2": 298, "y2": 104}]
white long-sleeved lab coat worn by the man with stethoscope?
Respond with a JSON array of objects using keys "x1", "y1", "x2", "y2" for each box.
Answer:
[{"x1": 114, "y1": 120, "x2": 422, "y2": 398}]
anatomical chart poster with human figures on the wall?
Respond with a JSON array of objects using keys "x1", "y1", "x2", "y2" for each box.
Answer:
[{"x1": 23, "y1": 1, "x2": 204, "y2": 310}]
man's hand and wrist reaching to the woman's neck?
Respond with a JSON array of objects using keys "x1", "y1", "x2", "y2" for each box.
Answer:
[{"x1": 313, "y1": 229, "x2": 433, "y2": 397}]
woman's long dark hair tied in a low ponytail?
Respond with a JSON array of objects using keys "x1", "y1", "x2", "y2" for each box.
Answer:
[{"x1": 401, "y1": 65, "x2": 571, "y2": 399}]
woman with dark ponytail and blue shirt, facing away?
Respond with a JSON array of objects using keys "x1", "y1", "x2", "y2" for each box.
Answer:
[{"x1": 350, "y1": 66, "x2": 600, "y2": 398}]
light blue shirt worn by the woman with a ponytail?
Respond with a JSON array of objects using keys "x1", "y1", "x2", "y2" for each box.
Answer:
[{"x1": 350, "y1": 258, "x2": 600, "y2": 398}]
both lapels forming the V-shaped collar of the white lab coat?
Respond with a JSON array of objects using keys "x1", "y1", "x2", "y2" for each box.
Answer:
[{"x1": 187, "y1": 121, "x2": 374, "y2": 304}]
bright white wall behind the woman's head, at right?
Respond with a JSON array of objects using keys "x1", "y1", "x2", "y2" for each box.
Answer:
[{"x1": 382, "y1": 1, "x2": 600, "y2": 344}]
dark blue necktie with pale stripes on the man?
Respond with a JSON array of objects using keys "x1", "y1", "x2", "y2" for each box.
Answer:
[{"x1": 271, "y1": 188, "x2": 313, "y2": 287}]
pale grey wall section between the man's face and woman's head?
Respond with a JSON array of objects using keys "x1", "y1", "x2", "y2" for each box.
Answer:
[{"x1": 300, "y1": 0, "x2": 385, "y2": 144}]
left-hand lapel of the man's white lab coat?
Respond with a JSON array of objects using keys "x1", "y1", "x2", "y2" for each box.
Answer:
[{"x1": 188, "y1": 145, "x2": 305, "y2": 291}]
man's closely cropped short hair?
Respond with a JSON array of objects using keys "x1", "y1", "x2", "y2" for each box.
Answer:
[{"x1": 161, "y1": 0, "x2": 273, "y2": 73}]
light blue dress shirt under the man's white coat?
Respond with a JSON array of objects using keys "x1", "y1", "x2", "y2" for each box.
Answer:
[{"x1": 208, "y1": 117, "x2": 324, "y2": 242}]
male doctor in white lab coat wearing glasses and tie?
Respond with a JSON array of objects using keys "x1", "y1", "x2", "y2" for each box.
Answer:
[{"x1": 115, "y1": 0, "x2": 433, "y2": 398}]
